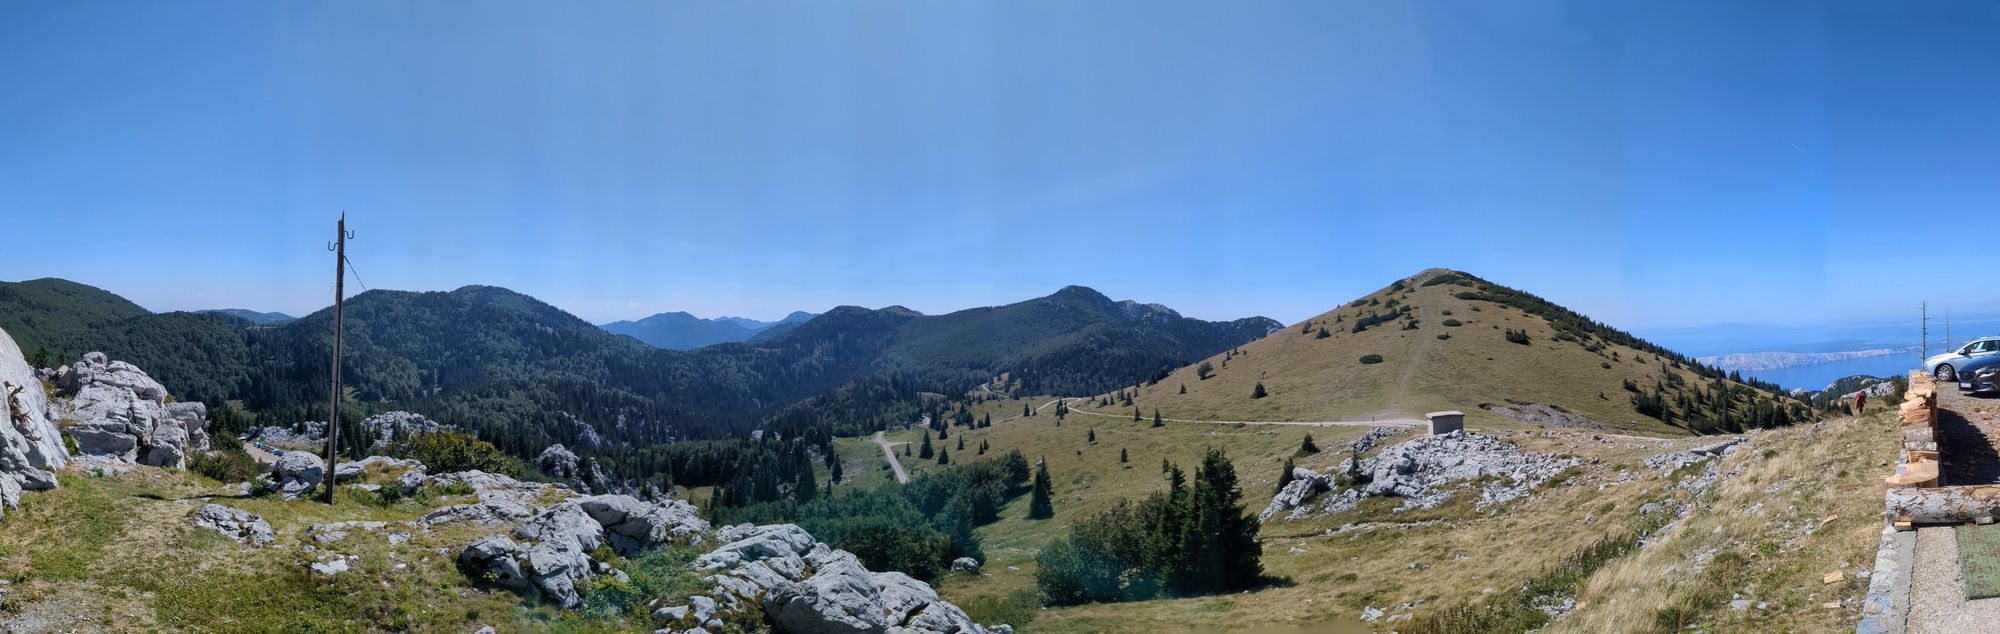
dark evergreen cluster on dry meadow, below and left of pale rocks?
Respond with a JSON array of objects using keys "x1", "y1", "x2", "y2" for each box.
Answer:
[{"x1": 1034, "y1": 450, "x2": 1264, "y2": 606}]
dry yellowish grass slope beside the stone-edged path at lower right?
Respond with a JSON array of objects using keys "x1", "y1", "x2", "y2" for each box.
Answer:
[{"x1": 1554, "y1": 416, "x2": 1894, "y2": 632}]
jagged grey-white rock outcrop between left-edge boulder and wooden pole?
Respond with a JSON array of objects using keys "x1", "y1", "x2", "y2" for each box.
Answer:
[{"x1": 52, "y1": 352, "x2": 208, "y2": 468}]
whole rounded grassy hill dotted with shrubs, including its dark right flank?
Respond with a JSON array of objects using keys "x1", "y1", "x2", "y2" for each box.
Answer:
[{"x1": 1078, "y1": 270, "x2": 1812, "y2": 434}]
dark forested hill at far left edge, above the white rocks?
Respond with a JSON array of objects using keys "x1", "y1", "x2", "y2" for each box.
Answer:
[{"x1": 0, "y1": 278, "x2": 150, "y2": 354}]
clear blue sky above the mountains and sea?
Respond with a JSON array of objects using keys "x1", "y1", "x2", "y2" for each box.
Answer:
[{"x1": 0, "y1": 0, "x2": 2000, "y2": 328}]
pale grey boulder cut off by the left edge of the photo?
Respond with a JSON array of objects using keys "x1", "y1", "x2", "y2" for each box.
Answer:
[{"x1": 0, "y1": 330, "x2": 68, "y2": 516}]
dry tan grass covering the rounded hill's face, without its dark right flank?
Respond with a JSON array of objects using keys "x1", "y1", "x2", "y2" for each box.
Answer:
[{"x1": 1084, "y1": 276, "x2": 1784, "y2": 436}]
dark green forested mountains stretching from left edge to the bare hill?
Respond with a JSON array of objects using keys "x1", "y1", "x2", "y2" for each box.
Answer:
[{"x1": 0, "y1": 280, "x2": 1278, "y2": 492}]
